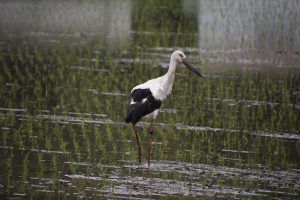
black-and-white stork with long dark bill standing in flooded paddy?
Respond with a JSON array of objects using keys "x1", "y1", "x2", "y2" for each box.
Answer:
[{"x1": 125, "y1": 50, "x2": 204, "y2": 167}]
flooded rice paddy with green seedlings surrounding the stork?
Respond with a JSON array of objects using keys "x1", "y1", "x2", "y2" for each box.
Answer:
[{"x1": 0, "y1": 1, "x2": 300, "y2": 199}]
